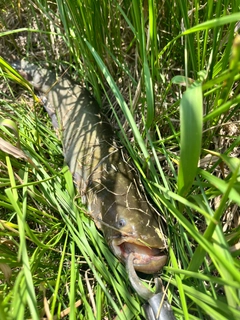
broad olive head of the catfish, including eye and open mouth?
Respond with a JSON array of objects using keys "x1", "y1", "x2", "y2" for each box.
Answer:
[{"x1": 99, "y1": 171, "x2": 167, "y2": 274}]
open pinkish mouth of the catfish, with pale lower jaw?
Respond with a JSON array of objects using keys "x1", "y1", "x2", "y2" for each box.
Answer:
[{"x1": 112, "y1": 239, "x2": 167, "y2": 274}]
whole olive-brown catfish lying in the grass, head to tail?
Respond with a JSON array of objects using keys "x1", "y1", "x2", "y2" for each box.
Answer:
[{"x1": 13, "y1": 61, "x2": 167, "y2": 273}]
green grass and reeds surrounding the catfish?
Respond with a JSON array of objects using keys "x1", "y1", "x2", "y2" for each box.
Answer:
[{"x1": 0, "y1": 0, "x2": 240, "y2": 320}]
